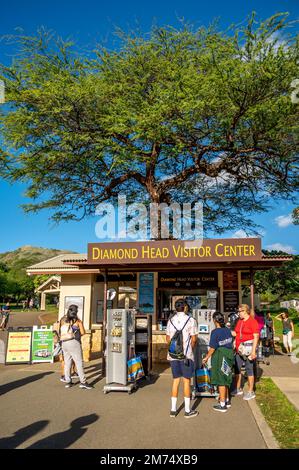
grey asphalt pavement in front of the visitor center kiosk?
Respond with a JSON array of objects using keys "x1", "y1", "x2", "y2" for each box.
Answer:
[{"x1": 0, "y1": 361, "x2": 266, "y2": 449}]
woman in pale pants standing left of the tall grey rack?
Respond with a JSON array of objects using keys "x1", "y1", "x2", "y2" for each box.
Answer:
[{"x1": 60, "y1": 305, "x2": 93, "y2": 390}]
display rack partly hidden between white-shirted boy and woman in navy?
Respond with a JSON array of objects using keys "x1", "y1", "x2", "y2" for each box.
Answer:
[{"x1": 192, "y1": 309, "x2": 216, "y2": 399}]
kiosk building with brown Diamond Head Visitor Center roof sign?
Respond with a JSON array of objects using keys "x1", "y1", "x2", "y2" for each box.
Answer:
[{"x1": 27, "y1": 238, "x2": 292, "y2": 362}]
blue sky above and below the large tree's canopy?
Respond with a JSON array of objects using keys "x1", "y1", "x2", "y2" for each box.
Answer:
[{"x1": 0, "y1": 0, "x2": 299, "y2": 253}]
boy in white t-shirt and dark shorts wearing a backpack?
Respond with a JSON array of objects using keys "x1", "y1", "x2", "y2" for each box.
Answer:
[{"x1": 166, "y1": 299, "x2": 198, "y2": 418}]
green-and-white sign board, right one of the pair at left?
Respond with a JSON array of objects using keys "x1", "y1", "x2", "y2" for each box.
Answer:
[{"x1": 32, "y1": 326, "x2": 54, "y2": 363}]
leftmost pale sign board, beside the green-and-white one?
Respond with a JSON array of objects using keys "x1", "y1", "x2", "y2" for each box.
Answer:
[{"x1": 5, "y1": 327, "x2": 32, "y2": 364}]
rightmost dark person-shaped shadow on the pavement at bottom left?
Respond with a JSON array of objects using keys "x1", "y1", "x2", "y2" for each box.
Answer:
[{"x1": 26, "y1": 413, "x2": 99, "y2": 449}]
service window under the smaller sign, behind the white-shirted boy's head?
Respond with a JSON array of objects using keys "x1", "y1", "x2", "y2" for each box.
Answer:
[{"x1": 158, "y1": 289, "x2": 219, "y2": 331}]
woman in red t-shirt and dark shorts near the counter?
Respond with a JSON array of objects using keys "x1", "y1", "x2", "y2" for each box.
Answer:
[{"x1": 232, "y1": 304, "x2": 259, "y2": 400}]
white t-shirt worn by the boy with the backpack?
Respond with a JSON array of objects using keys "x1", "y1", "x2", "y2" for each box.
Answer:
[{"x1": 166, "y1": 312, "x2": 198, "y2": 361}]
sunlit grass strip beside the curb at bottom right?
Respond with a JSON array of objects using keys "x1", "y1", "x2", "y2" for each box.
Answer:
[{"x1": 256, "y1": 378, "x2": 299, "y2": 449}]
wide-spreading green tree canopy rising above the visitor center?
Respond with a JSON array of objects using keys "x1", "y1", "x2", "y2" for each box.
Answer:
[{"x1": 0, "y1": 14, "x2": 299, "y2": 233}]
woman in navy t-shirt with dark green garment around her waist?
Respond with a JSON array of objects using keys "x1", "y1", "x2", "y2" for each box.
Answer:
[{"x1": 202, "y1": 312, "x2": 234, "y2": 413}]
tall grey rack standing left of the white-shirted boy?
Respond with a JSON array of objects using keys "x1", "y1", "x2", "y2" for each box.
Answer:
[{"x1": 103, "y1": 309, "x2": 135, "y2": 393}]
